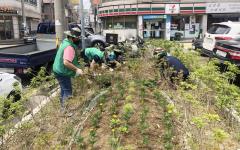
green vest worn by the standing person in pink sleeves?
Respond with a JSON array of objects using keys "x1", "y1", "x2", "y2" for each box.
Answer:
[{"x1": 53, "y1": 39, "x2": 80, "y2": 77}]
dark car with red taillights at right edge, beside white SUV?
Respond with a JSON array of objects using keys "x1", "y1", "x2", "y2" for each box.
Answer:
[{"x1": 213, "y1": 38, "x2": 240, "y2": 66}]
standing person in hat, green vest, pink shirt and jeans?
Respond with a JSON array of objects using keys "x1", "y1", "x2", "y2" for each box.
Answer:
[{"x1": 53, "y1": 28, "x2": 83, "y2": 111}]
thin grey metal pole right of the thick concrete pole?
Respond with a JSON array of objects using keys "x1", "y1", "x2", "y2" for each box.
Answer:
[{"x1": 79, "y1": 0, "x2": 85, "y2": 50}]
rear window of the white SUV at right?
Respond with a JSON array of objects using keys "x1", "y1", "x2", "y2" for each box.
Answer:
[{"x1": 208, "y1": 24, "x2": 231, "y2": 34}]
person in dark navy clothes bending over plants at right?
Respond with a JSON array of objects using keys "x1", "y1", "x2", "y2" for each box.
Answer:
[{"x1": 158, "y1": 50, "x2": 189, "y2": 82}]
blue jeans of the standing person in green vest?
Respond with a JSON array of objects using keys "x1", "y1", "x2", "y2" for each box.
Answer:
[{"x1": 55, "y1": 75, "x2": 72, "y2": 107}]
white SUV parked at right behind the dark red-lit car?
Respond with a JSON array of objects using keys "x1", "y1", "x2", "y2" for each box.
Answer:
[{"x1": 202, "y1": 21, "x2": 240, "y2": 56}]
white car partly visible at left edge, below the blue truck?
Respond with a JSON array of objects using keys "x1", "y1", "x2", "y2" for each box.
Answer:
[{"x1": 0, "y1": 72, "x2": 22, "y2": 101}]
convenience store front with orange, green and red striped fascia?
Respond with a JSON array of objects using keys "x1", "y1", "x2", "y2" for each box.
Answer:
[{"x1": 98, "y1": 3, "x2": 207, "y2": 40}]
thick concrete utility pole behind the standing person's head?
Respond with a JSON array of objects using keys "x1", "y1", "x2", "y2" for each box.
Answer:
[{"x1": 54, "y1": 0, "x2": 65, "y2": 46}]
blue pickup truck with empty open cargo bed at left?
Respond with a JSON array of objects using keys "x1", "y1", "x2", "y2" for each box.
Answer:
[{"x1": 0, "y1": 41, "x2": 56, "y2": 74}]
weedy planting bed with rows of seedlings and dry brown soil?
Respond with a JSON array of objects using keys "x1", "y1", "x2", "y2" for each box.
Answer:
[{"x1": 2, "y1": 40, "x2": 240, "y2": 150}]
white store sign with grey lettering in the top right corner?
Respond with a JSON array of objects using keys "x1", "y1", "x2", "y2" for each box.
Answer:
[{"x1": 206, "y1": 3, "x2": 240, "y2": 13}]
